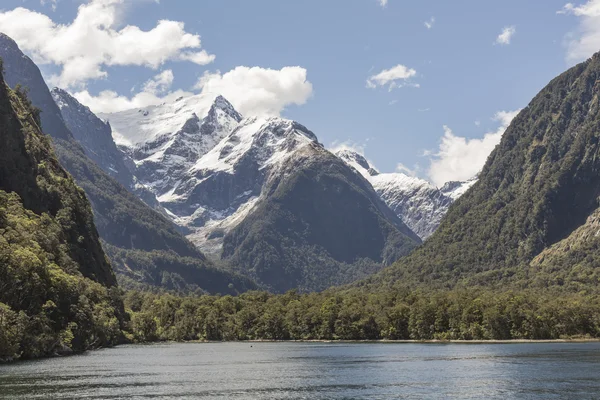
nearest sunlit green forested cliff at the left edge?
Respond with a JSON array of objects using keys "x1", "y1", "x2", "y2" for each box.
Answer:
[{"x1": 0, "y1": 68, "x2": 124, "y2": 360}]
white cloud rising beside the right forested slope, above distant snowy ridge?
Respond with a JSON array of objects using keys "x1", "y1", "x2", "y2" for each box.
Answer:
[{"x1": 428, "y1": 110, "x2": 521, "y2": 186}]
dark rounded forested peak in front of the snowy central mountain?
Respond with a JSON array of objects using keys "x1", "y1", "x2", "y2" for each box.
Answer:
[{"x1": 223, "y1": 144, "x2": 420, "y2": 293}]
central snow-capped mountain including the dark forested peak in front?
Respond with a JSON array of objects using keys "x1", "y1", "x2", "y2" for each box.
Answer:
[{"x1": 101, "y1": 94, "x2": 420, "y2": 291}]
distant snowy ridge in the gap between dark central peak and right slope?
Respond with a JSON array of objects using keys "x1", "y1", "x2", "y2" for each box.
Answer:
[{"x1": 335, "y1": 149, "x2": 475, "y2": 240}]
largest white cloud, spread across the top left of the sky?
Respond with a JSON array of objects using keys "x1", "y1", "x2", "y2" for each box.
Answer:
[{"x1": 0, "y1": 0, "x2": 215, "y2": 87}]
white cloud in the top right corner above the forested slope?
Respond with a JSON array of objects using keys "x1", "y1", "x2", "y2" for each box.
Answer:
[{"x1": 558, "y1": 0, "x2": 600, "y2": 64}]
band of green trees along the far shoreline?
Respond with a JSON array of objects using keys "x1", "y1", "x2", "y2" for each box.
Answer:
[{"x1": 124, "y1": 289, "x2": 600, "y2": 342}]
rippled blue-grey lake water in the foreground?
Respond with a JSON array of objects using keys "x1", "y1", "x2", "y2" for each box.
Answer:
[{"x1": 0, "y1": 343, "x2": 600, "y2": 400}]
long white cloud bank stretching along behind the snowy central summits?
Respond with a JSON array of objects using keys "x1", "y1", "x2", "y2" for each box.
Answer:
[{"x1": 74, "y1": 67, "x2": 312, "y2": 115}]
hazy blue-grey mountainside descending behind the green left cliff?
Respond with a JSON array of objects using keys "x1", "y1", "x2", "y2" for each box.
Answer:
[{"x1": 0, "y1": 35, "x2": 254, "y2": 293}]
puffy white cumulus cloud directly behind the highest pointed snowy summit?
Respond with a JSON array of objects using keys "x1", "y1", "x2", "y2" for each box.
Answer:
[{"x1": 195, "y1": 66, "x2": 313, "y2": 115}]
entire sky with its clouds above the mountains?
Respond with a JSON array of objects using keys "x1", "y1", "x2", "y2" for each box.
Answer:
[{"x1": 0, "y1": 0, "x2": 600, "y2": 186}]
